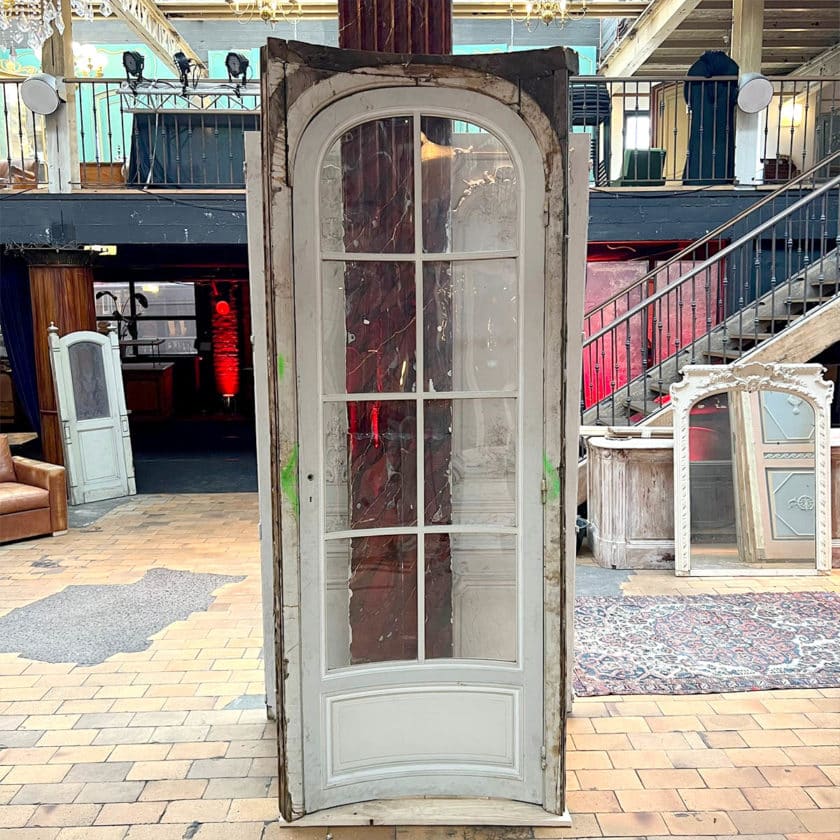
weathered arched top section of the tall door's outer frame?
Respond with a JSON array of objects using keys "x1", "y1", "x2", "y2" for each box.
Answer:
[{"x1": 263, "y1": 39, "x2": 577, "y2": 194}]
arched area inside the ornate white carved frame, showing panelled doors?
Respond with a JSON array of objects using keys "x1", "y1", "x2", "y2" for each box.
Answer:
[{"x1": 689, "y1": 391, "x2": 816, "y2": 571}]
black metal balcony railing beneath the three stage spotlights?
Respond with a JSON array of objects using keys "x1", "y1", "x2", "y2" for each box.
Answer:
[{"x1": 0, "y1": 79, "x2": 260, "y2": 190}]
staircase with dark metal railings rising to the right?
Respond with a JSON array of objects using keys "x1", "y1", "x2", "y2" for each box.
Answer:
[{"x1": 581, "y1": 151, "x2": 840, "y2": 426}]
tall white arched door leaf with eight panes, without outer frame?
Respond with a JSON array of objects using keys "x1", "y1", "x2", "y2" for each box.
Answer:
[{"x1": 294, "y1": 88, "x2": 544, "y2": 811}]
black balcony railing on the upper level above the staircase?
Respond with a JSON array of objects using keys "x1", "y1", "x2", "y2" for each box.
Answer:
[{"x1": 570, "y1": 76, "x2": 840, "y2": 188}]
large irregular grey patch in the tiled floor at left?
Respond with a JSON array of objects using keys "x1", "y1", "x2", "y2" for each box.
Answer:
[{"x1": 0, "y1": 569, "x2": 244, "y2": 665}]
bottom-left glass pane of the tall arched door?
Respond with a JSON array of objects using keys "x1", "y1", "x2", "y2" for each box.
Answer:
[{"x1": 324, "y1": 535, "x2": 417, "y2": 669}]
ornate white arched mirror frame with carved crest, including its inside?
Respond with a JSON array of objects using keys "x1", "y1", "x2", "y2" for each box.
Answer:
[{"x1": 671, "y1": 363, "x2": 834, "y2": 575}]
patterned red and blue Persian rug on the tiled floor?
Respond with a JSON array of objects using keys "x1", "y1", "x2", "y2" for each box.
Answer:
[{"x1": 574, "y1": 592, "x2": 840, "y2": 697}]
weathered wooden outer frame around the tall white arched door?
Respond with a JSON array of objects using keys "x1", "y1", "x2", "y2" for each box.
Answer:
[{"x1": 262, "y1": 40, "x2": 585, "y2": 820}]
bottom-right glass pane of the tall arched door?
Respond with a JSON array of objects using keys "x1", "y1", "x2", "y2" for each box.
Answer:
[{"x1": 425, "y1": 534, "x2": 517, "y2": 662}]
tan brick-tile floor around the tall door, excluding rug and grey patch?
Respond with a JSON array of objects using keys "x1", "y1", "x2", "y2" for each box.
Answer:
[{"x1": 0, "y1": 494, "x2": 840, "y2": 840}]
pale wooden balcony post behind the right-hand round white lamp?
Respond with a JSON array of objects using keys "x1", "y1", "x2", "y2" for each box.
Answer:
[{"x1": 731, "y1": 0, "x2": 766, "y2": 186}]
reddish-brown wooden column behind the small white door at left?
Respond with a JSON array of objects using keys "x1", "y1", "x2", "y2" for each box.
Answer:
[{"x1": 28, "y1": 251, "x2": 96, "y2": 464}]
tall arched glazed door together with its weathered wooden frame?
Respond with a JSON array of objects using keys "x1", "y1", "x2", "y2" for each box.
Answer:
[{"x1": 256, "y1": 39, "x2": 588, "y2": 825}]
